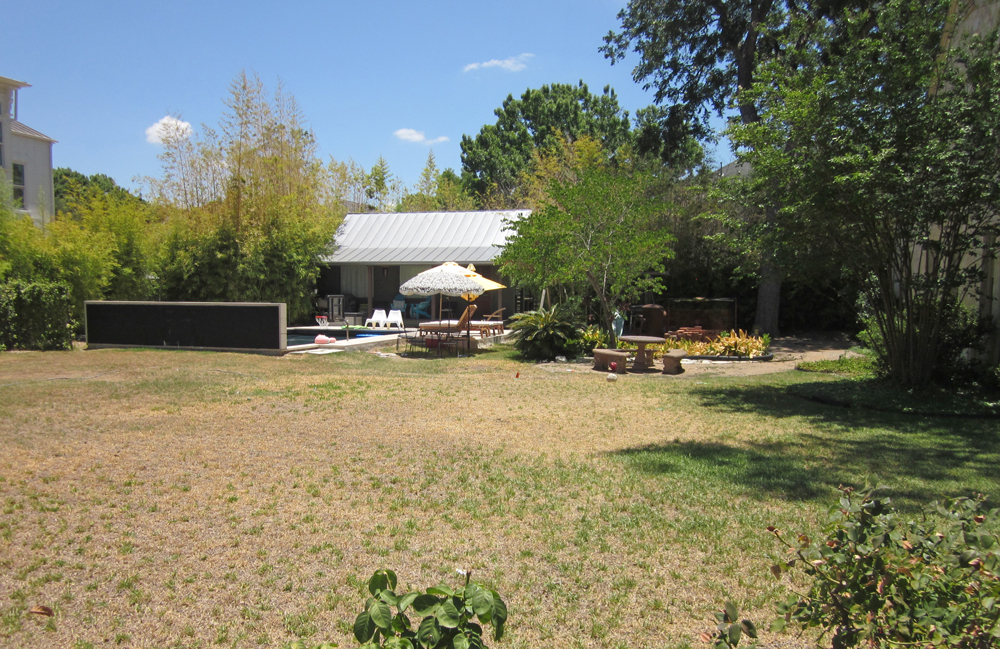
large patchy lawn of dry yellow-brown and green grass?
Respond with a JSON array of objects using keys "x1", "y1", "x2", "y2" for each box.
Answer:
[{"x1": 0, "y1": 351, "x2": 1000, "y2": 648}]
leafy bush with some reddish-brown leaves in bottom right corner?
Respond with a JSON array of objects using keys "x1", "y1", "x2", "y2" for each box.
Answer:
[{"x1": 768, "y1": 486, "x2": 1000, "y2": 649}]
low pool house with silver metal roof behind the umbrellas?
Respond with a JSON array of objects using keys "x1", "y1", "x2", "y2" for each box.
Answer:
[{"x1": 317, "y1": 210, "x2": 530, "y2": 317}]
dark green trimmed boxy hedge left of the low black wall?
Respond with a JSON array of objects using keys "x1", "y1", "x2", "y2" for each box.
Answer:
[{"x1": 0, "y1": 280, "x2": 74, "y2": 350}]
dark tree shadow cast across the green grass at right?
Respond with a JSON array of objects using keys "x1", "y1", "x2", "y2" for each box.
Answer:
[{"x1": 664, "y1": 383, "x2": 1000, "y2": 508}]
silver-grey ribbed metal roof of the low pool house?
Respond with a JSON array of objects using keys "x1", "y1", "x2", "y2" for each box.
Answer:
[{"x1": 324, "y1": 210, "x2": 531, "y2": 264}]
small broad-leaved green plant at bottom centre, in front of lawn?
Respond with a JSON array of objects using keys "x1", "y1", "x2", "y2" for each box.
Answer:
[{"x1": 292, "y1": 570, "x2": 507, "y2": 649}]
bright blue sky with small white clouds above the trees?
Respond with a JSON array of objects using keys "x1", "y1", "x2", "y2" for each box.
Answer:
[{"x1": 7, "y1": 0, "x2": 731, "y2": 192}]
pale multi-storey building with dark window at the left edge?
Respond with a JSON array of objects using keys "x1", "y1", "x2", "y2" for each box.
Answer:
[{"x1": 0, "y1": 77, "x2": 55, "y2": 227}]
